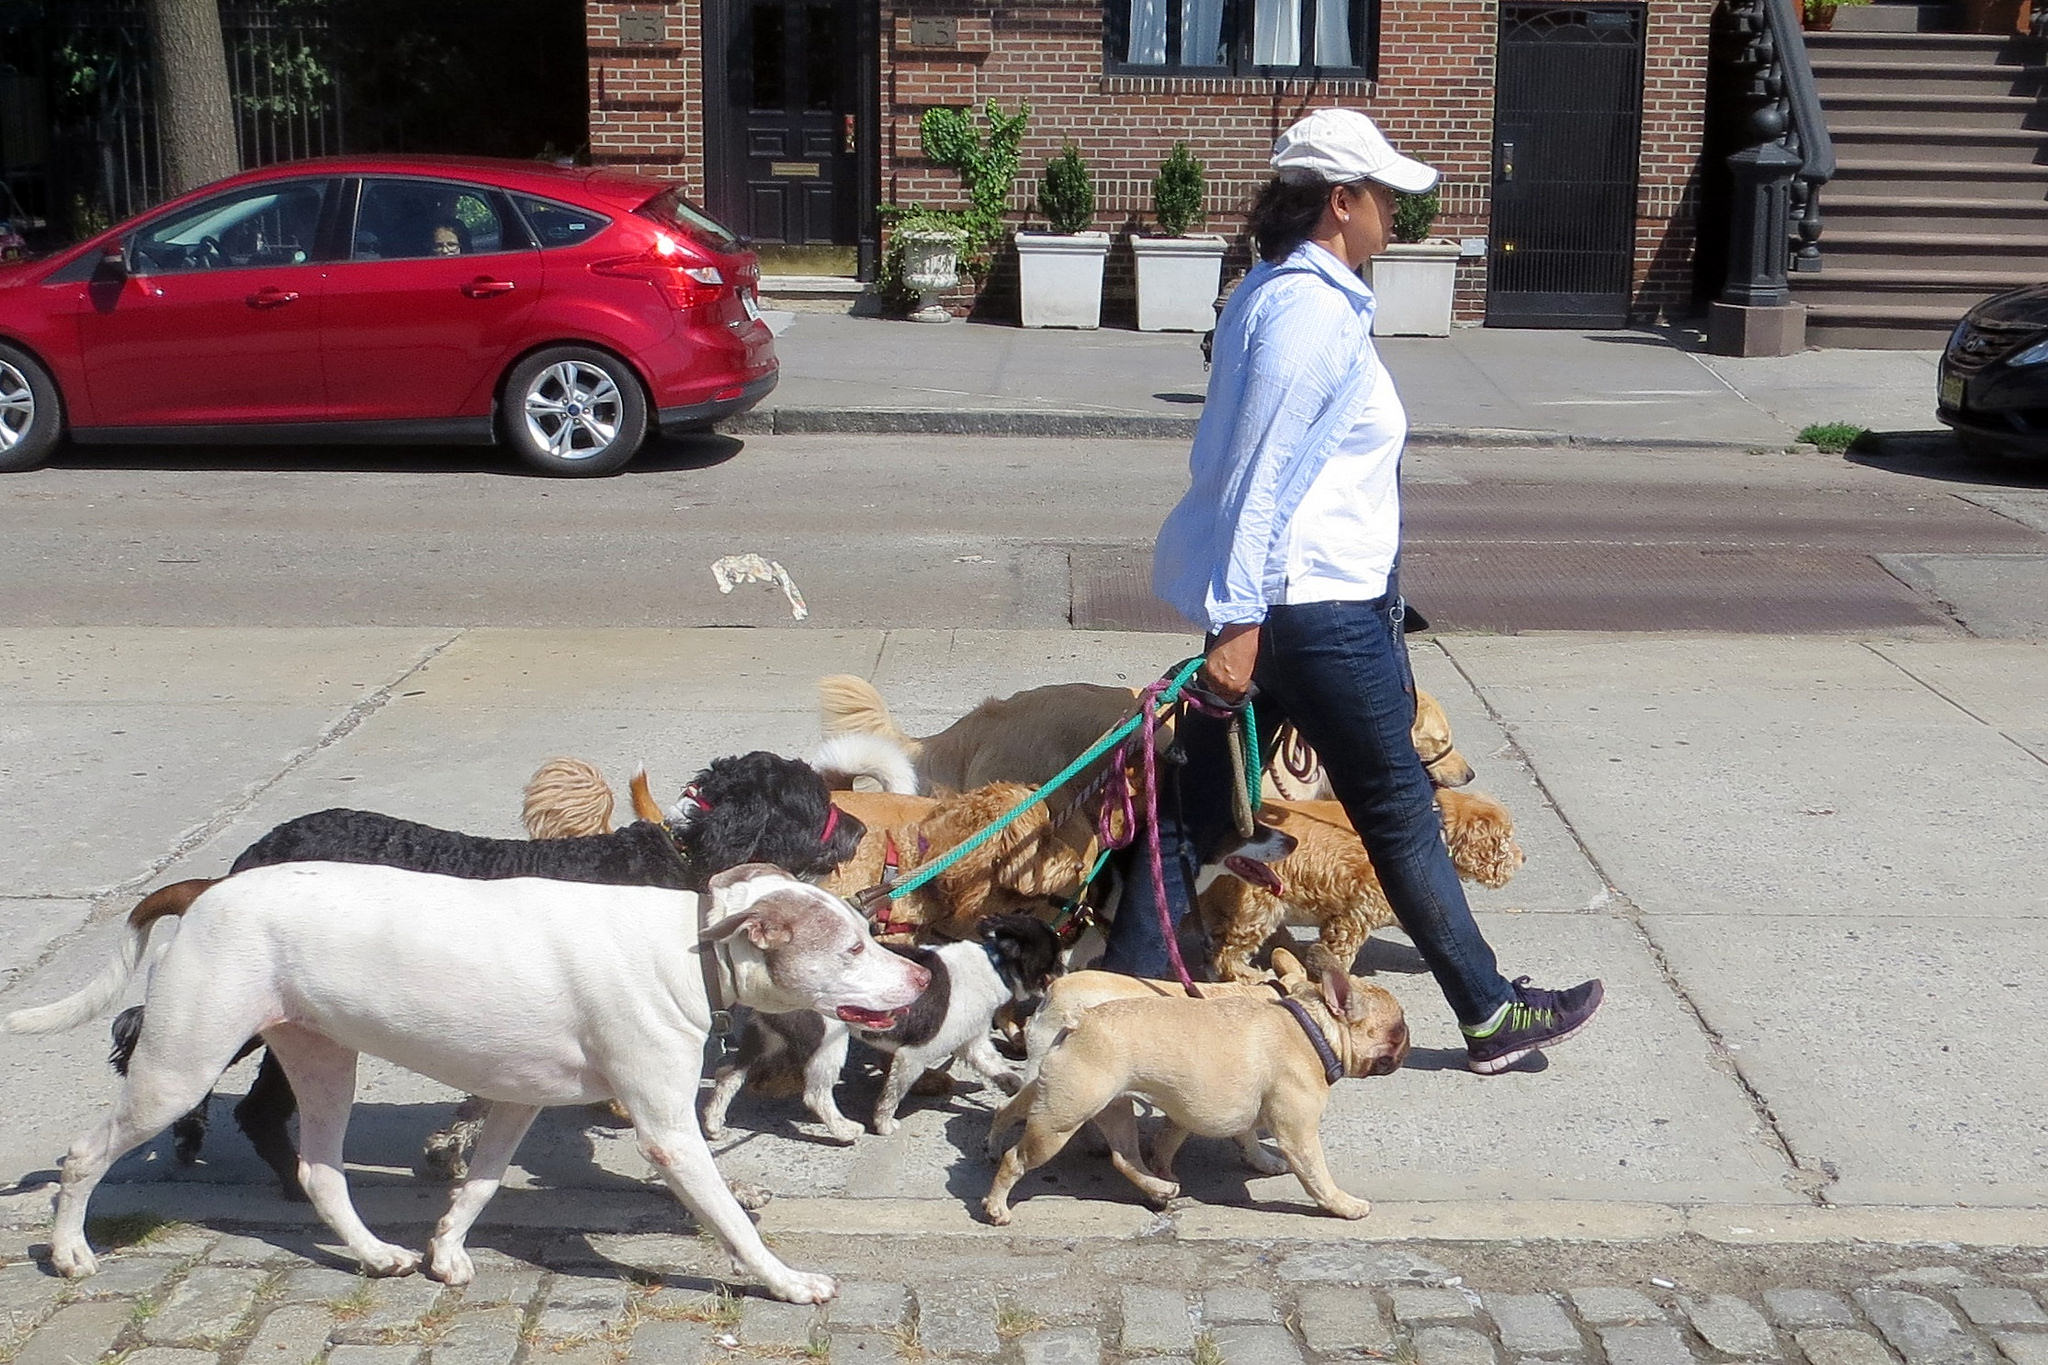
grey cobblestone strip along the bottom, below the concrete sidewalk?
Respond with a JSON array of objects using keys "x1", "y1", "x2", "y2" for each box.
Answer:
[{"x1": 0, "y1": 1218, "x2": 2048, "y2": 1365}]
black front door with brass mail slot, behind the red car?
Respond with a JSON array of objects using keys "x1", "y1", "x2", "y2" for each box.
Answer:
[{"x1": 705, "y1": 0, "x2": 864, "y2": 246}]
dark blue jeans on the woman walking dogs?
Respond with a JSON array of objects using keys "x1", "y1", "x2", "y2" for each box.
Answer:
[{"x1": 1102, "y1": 591, "x2": 1511, "y2": 1023}]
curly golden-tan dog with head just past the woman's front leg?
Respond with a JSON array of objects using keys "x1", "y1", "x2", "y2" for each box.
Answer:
[{"x1": 1200, "y1": 792, "x2": 1522, "y2": 980}]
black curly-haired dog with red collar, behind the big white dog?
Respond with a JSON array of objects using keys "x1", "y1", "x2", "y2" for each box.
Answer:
[{"x1": 106, "y1": 751, "x2": 866, "y2": 1199}]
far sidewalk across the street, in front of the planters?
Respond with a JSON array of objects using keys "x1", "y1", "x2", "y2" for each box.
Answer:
[{"x1": 731, "y1": 313, "x2": 1939, "y2": 448}]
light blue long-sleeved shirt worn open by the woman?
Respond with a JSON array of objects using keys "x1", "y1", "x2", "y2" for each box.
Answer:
[{"x1": 1153, "y1": 241, "x2": 1380, "y2": 630}]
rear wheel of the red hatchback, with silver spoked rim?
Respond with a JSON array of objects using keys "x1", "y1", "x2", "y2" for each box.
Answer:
[{"x1": 498, "y1": 346, "x2": 647, "y2": 479}]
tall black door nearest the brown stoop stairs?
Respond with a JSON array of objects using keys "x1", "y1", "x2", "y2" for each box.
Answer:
[{"x1": 1487, "y1": 0, "x2": 1642, "y2": 327}]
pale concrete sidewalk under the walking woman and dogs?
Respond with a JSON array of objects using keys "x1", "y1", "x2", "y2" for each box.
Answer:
[{"x1": 0, "y1": 628, "x2": 2048, "y2": 1246}]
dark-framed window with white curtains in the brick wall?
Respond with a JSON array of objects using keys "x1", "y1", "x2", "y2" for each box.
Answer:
[{"x1": 1104, "y1": 0, "x2": 1378, "y2": 80}]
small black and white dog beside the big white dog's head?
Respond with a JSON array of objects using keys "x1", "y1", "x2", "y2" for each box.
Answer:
[{"x1": 705, "y1": 915, "x2": 1061, "y2": 1142}]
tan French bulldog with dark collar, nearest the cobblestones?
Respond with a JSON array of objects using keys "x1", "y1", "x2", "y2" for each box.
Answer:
[{"x1": 981, "y1": 972, "x2": 1409, "y2": 1224}]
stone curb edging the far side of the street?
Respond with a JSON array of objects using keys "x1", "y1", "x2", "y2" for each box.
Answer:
[{"x1": 717, "y1": 407, "x2": 1792, "y2": 450}]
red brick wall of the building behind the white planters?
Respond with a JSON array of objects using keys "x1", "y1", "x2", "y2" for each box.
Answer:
[{"x1": 586, "y1": 0, "x2": 1714, "y2": 321}]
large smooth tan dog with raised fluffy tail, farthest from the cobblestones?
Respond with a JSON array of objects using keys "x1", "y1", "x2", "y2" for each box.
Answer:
[{"x1": 817, "y1": 673, "x2": 1473, "y2": 796}]
